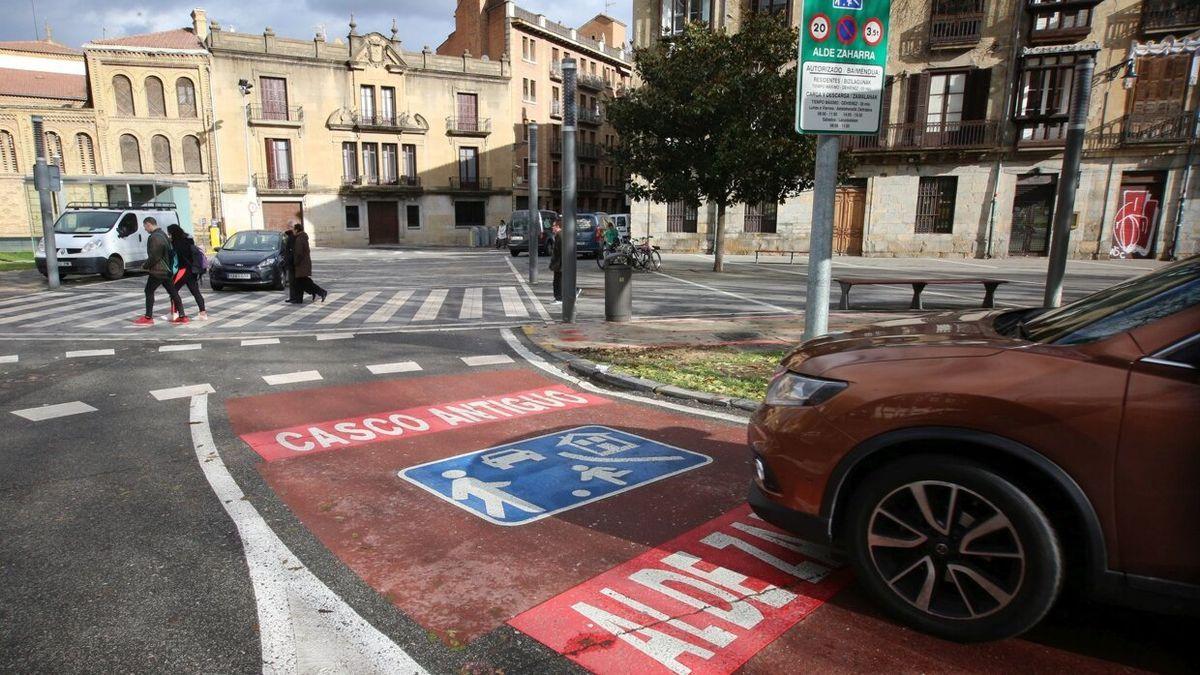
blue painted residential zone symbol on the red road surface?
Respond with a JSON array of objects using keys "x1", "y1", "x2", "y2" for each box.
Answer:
[{"x1": 400, "y1": 426, "x2": 713, "y2": 525}]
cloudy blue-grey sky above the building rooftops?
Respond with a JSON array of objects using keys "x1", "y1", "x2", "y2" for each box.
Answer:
[{"x1": 0, "y1": 0, "x2": 632, "y2": 50}]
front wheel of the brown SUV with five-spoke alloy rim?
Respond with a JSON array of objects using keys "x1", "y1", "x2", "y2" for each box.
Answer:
[{"x1": 845, "y1": 455, "x2": 1063, "y2": 641}]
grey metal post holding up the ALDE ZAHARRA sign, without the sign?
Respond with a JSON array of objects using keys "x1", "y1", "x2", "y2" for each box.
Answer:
[{"x1": 804, "y1": 133, "x2": 840, "y2": 340}]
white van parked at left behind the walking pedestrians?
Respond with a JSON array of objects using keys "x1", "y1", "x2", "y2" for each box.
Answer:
[{"x1": 34, "y1": 202, "x2": 179, "y2": 279}]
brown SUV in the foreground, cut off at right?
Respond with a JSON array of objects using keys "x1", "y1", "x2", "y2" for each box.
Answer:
[{"x1": 749, "y1": 257, "x2": 1200, "y2": 641}]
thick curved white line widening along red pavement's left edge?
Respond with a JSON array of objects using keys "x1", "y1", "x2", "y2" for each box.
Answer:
[{"x1": 188, "y1": 394, "x2": 426, "y2": 675}]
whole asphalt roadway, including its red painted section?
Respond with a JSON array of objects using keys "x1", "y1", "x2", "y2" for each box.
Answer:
[{"x1": 0, "y1": 251, "x2": 1196, "y2": 673}]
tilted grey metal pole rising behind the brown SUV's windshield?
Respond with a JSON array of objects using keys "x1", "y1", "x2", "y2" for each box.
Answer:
[{"x1": 1044, "y1": 56, "x2": 1096, "y2": 307}]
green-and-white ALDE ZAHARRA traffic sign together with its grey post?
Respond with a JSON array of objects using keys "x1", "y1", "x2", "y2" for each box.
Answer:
[{"x1": 796, "y1": 0, "x2": 892, "y2": 340}]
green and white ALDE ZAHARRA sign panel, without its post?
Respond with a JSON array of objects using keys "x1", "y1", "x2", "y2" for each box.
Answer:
[{"x1": 796, "y1": 0, "x2": 892, "y2": 133}]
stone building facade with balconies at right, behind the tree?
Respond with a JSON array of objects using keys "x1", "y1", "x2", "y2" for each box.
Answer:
[{"x1": 631, "y1": 0, "x2": 1200, "y2": 258}]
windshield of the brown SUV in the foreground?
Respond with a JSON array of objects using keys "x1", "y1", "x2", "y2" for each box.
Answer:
[{"x1": 1021, "y1": 257, "x2": 1200, "y2": 345}]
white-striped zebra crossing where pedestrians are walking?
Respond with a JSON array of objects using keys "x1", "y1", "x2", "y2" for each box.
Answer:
[{"x1": 0, "y1": 286, "x2": 538, "y2": 338}]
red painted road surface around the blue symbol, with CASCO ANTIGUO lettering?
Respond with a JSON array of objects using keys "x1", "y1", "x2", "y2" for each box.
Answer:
[{"x1": 227, "y1": 368, "x2": 1180, "y2": 674}]
